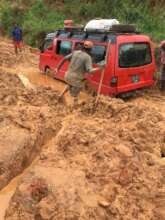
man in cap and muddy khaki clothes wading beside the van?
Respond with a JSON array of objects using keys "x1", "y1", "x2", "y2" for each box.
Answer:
[{"x1": 55, "y1": 41, "x2": 104, "y2": 107}]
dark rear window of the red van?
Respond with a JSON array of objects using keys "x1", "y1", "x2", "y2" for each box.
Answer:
[{"x1": 119, "y1": 43, "x2": 152, "y2": 68}]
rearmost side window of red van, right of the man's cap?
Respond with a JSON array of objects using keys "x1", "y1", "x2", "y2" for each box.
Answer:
[{"x1": 91, "y1": 45, "x2": 106, "y2": 63}]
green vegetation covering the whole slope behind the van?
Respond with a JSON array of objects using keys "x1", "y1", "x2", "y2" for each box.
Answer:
[{"x1": 0, "y1": 0, "x2": 165, "y2": 45}]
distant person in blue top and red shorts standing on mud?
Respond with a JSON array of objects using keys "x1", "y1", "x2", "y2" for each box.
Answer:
[{"x1": 12, "y1": 24, "x2": 22, "y2": 55}]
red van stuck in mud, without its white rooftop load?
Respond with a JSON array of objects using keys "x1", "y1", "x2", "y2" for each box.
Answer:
[{"x1": 39, "y1": 27, "x2": 156, "y2": 96}]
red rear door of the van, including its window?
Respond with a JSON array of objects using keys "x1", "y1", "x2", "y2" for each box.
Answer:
[{"x1": 115, "y1": 35, "x2": 155, "y2": 93}]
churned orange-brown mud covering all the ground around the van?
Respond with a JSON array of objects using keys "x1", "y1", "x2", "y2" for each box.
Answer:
[{"x1": 0, "y1": 40, "x2": 165, "y2": 220}]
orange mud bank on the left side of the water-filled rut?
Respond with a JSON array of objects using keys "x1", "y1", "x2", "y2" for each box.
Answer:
[{"x1": 0, "y1": 73, "x2": 64, "y2": 189}]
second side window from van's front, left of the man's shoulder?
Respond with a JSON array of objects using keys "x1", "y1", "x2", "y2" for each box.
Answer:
[{"x1": 56, "y1": 41, "x2": 72, "y2": 56}]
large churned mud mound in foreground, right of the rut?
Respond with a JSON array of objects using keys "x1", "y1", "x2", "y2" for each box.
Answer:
[{"x1": 3, "y1": 97, "x2": 165, "y2": 220}]
